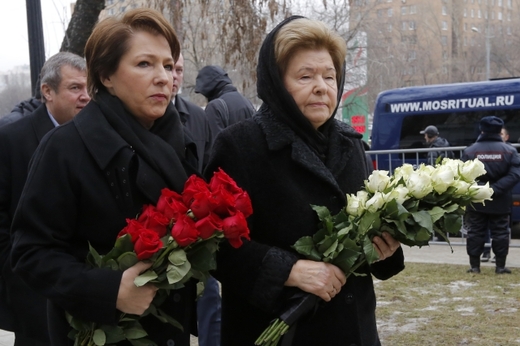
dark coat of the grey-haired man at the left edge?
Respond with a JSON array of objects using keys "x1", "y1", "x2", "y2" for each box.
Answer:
[{"x1": 0, "y1": 105, "x2": 54, "y2": 342}]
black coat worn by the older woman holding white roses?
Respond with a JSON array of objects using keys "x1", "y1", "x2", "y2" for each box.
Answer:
[{"x1": 206, "y1": 112, "x2": 404, "y2": 346}]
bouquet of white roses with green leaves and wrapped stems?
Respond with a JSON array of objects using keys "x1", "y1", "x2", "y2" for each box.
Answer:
[{"x1": 255, "y1": 158, "x2": 493, "y2": 346}]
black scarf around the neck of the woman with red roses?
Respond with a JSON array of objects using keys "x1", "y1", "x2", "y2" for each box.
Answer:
[{"x1": 95, "y1": 91, "x2": 188, "y2": 193}]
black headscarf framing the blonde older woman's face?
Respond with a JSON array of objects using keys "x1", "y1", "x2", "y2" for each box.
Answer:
[{"x1": 256, "y1": 16, "x2": 345, "y2": 160}]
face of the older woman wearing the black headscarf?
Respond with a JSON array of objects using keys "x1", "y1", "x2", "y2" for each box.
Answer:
[{"x1": 283, "y1": 49, "x2": 338, "y2": 129}]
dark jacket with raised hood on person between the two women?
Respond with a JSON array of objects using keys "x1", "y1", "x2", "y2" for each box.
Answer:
[{"x1": 195, "y1": 66, "x2": 255, "y2": 138}]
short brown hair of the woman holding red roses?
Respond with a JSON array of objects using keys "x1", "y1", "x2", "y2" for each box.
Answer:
[{"x1": 85, "y1": 8, "x2": 181, "y2": 99}]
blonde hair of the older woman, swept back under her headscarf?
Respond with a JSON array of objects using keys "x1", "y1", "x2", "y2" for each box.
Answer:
[{"x1": 274, "y1": 18, "x2": 347, "y2": 80}]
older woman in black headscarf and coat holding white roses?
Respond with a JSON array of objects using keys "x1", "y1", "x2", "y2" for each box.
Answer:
[{"x1": 206, "y1": 17, "x2": 404, "y2": 346}]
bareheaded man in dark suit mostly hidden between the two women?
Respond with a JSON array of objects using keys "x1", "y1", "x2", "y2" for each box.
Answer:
[{"x1": 172, "y1": 53, "x2": 221, "y2": 346}]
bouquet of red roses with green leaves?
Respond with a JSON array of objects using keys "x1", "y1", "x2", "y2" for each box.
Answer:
[{"x1": 67, "y1": 169, "x2": 253, "y2": 346}]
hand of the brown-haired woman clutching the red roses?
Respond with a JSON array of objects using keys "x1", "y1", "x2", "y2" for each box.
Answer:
[{"x1": 116, "y1": 262, "x2": 158, "y2": 315}]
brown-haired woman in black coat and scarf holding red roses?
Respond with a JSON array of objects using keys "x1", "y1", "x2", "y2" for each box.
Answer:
[{"x1": 11, "y1": 9, "x2": 196, "y2": 346}]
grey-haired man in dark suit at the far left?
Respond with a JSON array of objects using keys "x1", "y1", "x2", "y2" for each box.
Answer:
[{"x1": 0, "y1": 52, "x2": 90, "y2": 346}]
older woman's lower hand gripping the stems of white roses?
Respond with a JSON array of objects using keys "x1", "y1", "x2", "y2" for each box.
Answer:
[{"x1": 285, "y1": 260, "x2": 347, "y2": 302}]
